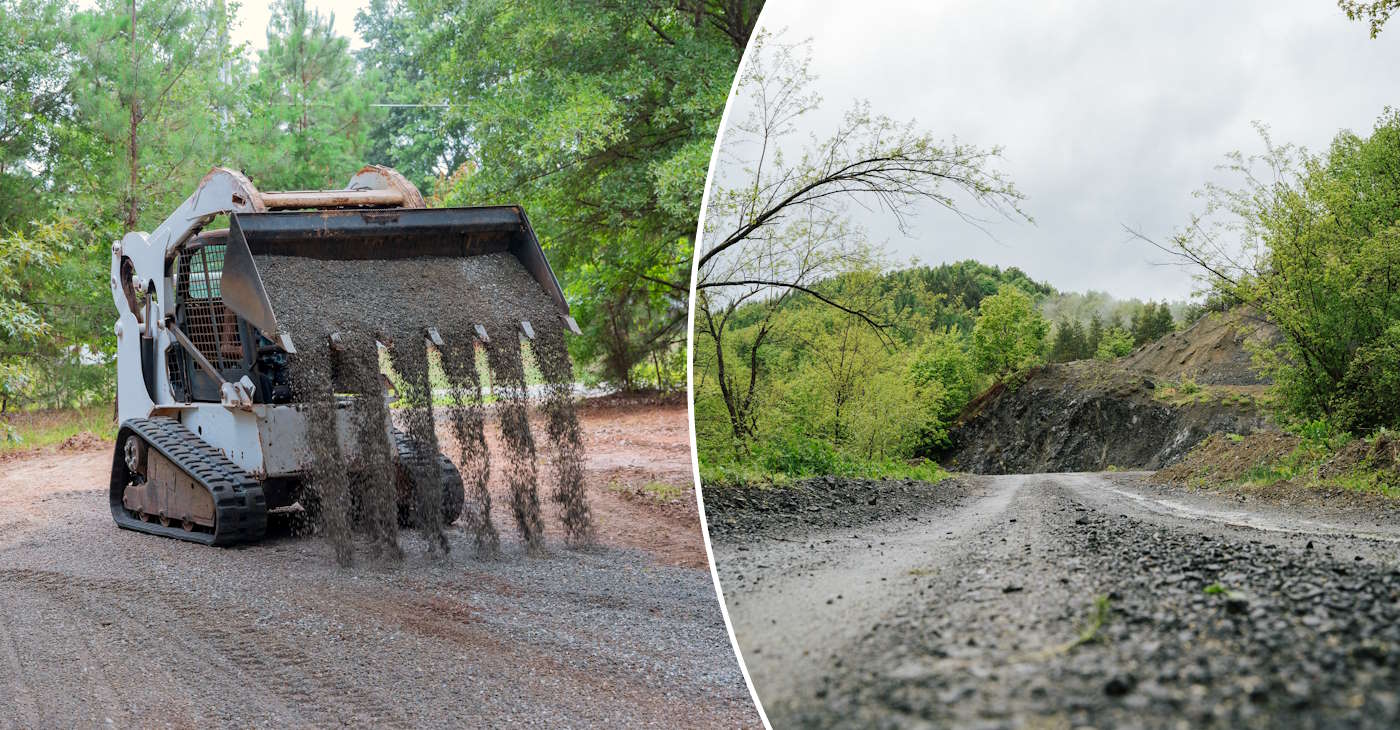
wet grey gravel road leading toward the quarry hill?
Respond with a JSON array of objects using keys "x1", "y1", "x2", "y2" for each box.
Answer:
[{"x1": 706, "y1": 474, "x2": 1400, "y2": 729}]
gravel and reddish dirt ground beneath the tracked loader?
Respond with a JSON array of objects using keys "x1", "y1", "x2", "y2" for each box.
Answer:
[{"x1": 0, "y1": 402, "x2": 759, "y2": 729}]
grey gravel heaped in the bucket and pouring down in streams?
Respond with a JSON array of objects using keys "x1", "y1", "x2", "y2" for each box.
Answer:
[{"x1": 256, "y1": 254, "x2": 592, "y2": 563}]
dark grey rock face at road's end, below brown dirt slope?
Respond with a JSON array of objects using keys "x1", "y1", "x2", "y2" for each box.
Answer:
[{"x1": 944, "y1": 360, "x2": 1270, "y2": 474}]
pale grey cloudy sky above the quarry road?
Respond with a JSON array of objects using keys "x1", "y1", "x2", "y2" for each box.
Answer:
[{"x1": 731, "y1": 0, "x2": 1400, "y2": 298}]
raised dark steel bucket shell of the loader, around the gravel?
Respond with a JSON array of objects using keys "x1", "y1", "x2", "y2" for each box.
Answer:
[{"x1": 221, "y1": 206, "x2": 568, "y2": 342}]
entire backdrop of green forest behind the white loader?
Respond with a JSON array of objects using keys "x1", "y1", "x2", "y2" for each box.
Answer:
[{"x1": 0, "y1": 0, "x2": 762, "y2": 409}]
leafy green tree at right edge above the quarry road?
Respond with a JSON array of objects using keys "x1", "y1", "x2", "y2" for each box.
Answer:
[{"x1": 1166, "y1": 111, "x2": 1400, "y2": 433}]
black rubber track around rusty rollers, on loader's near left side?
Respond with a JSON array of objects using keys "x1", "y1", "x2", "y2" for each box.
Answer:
[{"x1": 109, "y1": 416, "x2": 267, "y2": 545}]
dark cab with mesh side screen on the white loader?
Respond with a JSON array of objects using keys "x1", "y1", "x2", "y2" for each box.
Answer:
[{"x1": 165, "y1": 230, "x2": 291, "y2": 404}]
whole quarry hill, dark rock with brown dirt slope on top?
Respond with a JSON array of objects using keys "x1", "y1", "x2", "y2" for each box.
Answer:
[{"x1": 942, "y1": 312, "x2": 1277, "y2": 474}]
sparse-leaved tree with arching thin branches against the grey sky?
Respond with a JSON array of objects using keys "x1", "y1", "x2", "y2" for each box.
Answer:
[{"x1": 694, "y1": 36, "x2": 1021, "y2": 443}]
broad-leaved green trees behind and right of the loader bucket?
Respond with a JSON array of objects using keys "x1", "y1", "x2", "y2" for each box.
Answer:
[{"x1": 398, "y1": 0, "x2": 762, "y2": 385}]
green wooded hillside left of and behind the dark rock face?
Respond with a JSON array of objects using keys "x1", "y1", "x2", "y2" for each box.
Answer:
[{"x1": 696, "y1": 261, "x2": 1203, "y2": 481}]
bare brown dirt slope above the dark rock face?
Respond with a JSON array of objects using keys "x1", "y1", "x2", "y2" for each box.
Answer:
[{"x1": 1117, "y1": 310, "x2": 1280, "y2": 385}]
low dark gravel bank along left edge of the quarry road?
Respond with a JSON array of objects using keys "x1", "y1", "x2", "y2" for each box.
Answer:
[{"x1": 704, "y1": 476, "x2": 966, "y2": 539}]
